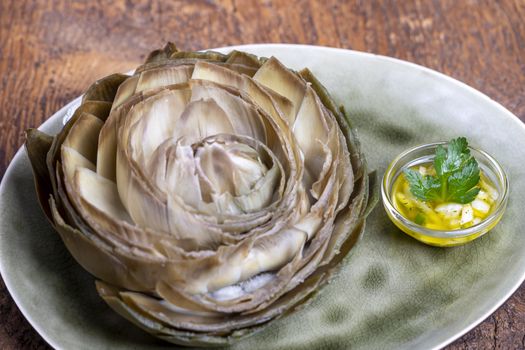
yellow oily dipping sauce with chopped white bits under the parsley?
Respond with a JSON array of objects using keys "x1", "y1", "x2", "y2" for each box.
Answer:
[{"x1": 392, "y1": 163, "x2": 499, "y2": 230}]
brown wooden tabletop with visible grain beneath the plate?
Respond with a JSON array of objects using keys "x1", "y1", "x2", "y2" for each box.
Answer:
[{"x1": 0, "y1": 0, "x2": 525, "y2": 349}]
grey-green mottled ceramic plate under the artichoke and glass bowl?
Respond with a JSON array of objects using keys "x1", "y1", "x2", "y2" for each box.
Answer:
[{"x1": 0, "y1": 45, "x2": 525, "y2": 349}]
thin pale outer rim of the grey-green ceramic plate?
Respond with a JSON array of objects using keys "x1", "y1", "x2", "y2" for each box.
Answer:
[{"x1": 0, "y1": 43, "x2": 525, "y2": 349}]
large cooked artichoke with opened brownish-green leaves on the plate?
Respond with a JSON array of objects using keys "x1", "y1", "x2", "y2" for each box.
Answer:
[{"x1": 26, "y1": 43, "x2": 371, "y2": 346}]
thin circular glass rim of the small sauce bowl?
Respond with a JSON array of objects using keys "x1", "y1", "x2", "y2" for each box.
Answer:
[{"x1": 381, "y1": 141, "x2": 509, "y2": 238}]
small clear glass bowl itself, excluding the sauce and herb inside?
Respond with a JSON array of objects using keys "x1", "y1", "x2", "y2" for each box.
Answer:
[{"x1": 381, "y1": 142, "x2": 509, "y2": 247}]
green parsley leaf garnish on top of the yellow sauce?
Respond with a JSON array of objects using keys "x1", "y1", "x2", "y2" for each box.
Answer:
[{"x1": 404, "y1": 137, "x2": 479, "y2": 204}]
